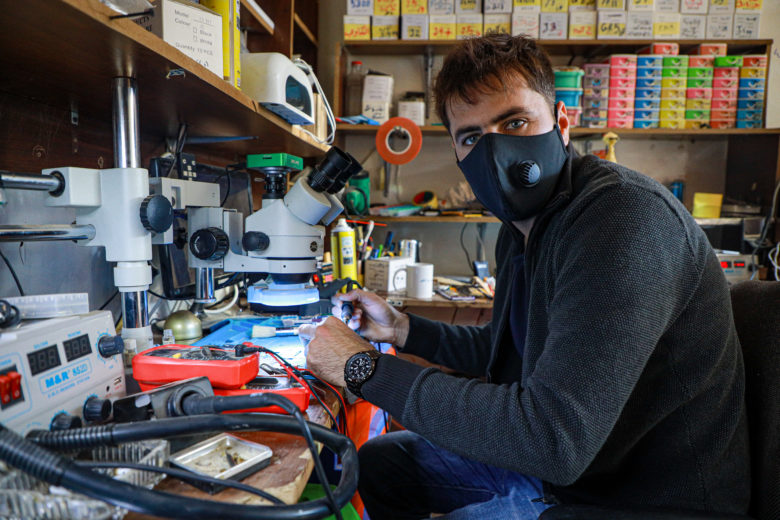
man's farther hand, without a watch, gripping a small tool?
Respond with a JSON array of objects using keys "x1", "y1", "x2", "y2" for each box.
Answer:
[{"x1": 331, "y1": 289, "x2": 409, "y2": 347}]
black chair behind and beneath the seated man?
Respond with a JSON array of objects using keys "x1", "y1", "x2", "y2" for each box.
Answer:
[{"x1": 539, "y1": 281, "x2": 780, "y2": 520}]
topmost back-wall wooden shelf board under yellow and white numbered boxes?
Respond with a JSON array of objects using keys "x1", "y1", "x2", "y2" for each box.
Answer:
[{"x1": 344, "y1": 40, "x2": 772, "y2": 57}]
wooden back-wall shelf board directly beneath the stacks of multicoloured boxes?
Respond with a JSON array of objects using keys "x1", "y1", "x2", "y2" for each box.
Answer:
[{"x1": 336, "y1": 124, "x2": 780, "y2": 138}]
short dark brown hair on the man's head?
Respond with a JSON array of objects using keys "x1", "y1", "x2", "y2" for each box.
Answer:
[{"x1": 433, "y1": 34, "x2": 555, "y2": 130}]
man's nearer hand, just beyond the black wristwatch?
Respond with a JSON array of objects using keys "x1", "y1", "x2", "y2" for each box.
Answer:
[{"x1": 298, "y1": 316, "x2": 374, "y2": 387}]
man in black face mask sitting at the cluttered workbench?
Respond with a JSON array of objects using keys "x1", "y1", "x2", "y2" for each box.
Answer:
[{"x1": 303, "y1": 35, "x2": 749, "y2": 520}]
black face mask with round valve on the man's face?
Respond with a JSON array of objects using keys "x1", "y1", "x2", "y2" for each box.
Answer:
[{"x1": 458, "y1": 124, "x2": 569, "y2": 222}]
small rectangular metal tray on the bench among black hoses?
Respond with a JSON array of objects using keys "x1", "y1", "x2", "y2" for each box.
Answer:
[{"x1": 168, "y1": 433, "x2": 273, "y2": 493}]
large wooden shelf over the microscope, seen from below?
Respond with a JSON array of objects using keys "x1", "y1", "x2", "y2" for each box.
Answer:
[{"x1": 0, "y1": 0, "x2": 328, "y2": 157}]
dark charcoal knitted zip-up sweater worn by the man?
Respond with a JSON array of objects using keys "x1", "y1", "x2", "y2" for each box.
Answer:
[{"x1": 363, "y1": 149, "x2": 750, "y2": 513}]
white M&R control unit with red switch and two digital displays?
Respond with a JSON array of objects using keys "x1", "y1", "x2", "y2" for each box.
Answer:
[{"x1": 0, "y1": 311, "x2": 125, "y2": 434}]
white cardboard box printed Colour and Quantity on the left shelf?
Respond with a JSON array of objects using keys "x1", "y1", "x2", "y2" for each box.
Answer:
[{"x1": 135, "y1": 0, "x2": 224, "y2": 78}]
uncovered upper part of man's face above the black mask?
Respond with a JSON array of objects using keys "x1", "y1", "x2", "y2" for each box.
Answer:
[{"x1": 447, "y1": 77, "x2": 569, "y2": 161}]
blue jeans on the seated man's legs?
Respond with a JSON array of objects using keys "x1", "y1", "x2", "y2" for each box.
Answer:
[{"x1": 358, "y1": 431, "x2": 549, "y2": 520}]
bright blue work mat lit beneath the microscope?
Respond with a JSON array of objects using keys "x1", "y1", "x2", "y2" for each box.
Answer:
[{"x1": 193, "y1": 316, "x2": 306, "y2": 367}]
